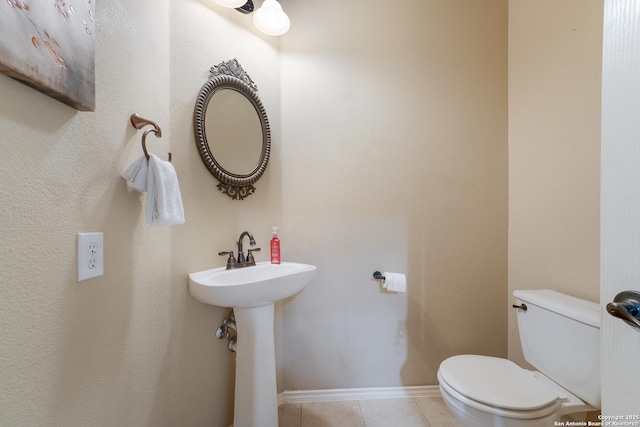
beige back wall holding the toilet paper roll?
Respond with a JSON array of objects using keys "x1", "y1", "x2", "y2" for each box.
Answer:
[{"x1": 281, "y1": 0, "x2": 507, "y2": 389}]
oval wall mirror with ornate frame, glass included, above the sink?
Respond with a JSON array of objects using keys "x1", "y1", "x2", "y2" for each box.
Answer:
[{"x1": 194, "y1": 59, "x2": 271, "y2": 200}]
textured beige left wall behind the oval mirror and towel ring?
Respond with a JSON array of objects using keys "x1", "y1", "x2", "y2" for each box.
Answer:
[{"x1": 0, "y1": 0, "x2": 280, "y2": 427}]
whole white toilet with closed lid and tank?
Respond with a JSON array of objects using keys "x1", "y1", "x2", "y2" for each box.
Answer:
[{"x1": 438, "y1": 289, "x2": 600, "y2": 427}]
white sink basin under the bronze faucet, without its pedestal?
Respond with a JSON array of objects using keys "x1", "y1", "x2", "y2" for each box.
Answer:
[{"x1": 189, "y1": 262, "x2": 316, "y2": 307}]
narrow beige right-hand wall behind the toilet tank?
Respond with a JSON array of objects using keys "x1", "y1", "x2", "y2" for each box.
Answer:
[{"x1": 509, "y1": 0, "x2": 603, "y2": 361}]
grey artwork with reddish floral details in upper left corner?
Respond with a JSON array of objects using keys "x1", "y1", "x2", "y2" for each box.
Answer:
[{"x1": 0, "y1": 0, "x2": 95, "y2": 111}]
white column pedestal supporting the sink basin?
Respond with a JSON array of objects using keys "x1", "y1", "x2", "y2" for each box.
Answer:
[{"x1": 233, "y1": 303, "x2": 278, "y2": 427}]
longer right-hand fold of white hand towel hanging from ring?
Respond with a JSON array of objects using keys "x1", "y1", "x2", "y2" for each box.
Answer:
[{"x1": 147, "y1": 153, "x2": 184, "y2": 226}]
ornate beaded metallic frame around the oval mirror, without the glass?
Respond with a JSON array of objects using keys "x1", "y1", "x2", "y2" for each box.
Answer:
[{"x1": 193, "y1": 59, "x2": 271, "y2": 200}]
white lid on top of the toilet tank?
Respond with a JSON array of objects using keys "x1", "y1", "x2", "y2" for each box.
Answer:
[{"x1": 513, "y1": 289, "x2": 600, "y2": 328}]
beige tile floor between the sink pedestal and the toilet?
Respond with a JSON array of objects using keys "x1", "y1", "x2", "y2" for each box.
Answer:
[{"x1": 278, "y1": 397, "x2": 460, "y2": 427}]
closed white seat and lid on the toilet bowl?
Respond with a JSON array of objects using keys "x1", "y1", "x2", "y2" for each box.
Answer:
[{"x1": 438, "y1": 355, "x2": 561, "y2": 418}]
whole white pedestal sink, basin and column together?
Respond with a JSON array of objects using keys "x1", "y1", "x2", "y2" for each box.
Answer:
[{"x1": 189, "y1": 262, "x2": 316, "y2": 427}]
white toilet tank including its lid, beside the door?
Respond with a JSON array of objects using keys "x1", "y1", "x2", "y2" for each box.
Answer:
[{"x1": 513, "y1": 289, "x2": 600, "y2": 408}]
